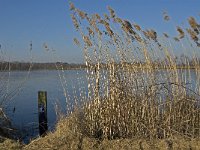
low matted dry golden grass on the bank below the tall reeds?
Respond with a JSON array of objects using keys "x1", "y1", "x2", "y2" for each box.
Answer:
[{"x1": 23, "y1": 116, "x2": 200, "y2": 150}]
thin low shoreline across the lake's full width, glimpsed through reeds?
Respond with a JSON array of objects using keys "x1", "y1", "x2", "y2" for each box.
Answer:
[{"x1": 0, "y1": 62, "x2": 200, "y2": 72}]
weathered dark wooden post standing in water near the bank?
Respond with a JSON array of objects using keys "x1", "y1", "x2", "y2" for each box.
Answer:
[{"x1": 38, "y1": 91, "x2": 48, "y2": 136}]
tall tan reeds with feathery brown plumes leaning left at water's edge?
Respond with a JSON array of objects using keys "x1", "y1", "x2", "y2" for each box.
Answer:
[{"x1": 67, "y1": 3, "x2": 200, "y2": 139}]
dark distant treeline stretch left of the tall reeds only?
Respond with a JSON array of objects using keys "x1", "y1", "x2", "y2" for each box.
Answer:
[{"x1": 0, "y1": 62, "x2": 85, "y2": 71}]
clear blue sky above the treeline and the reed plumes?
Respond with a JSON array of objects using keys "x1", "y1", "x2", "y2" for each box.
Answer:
[{"x1": 0, "y1": 0, "x2": 200, "y2": 63}]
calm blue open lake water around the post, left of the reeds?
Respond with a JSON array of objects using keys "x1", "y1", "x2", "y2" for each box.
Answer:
[{"x1": 0, "y1": 70, "x2": 86, "y2": 141}]
